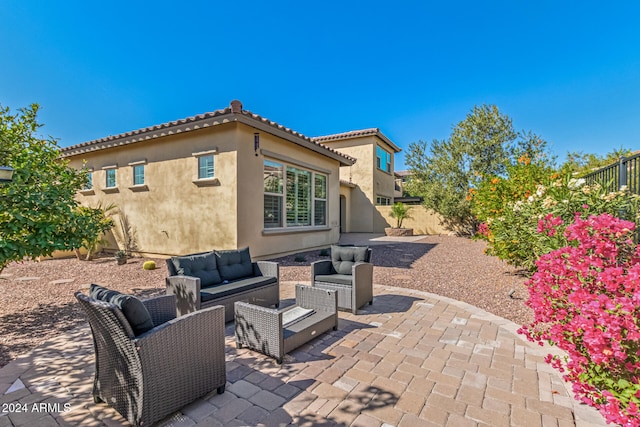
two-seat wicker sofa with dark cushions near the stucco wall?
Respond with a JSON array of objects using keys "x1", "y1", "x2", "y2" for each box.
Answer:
[{"x1": 166, "y1": 248, "x2": 280, "y2": 322}]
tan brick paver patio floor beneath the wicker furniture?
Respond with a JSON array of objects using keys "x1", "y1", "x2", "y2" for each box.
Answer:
[{"x1": 0, "y1": 282, "x2": 606, "y2": 427}]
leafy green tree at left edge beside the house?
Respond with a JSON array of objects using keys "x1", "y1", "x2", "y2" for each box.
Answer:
[{"x1": 0, "y1": 104, "x2": 113, "y2": 271}]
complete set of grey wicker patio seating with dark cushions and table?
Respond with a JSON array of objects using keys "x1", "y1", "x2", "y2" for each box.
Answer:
[{"x1": 75, "y1": 246, "x2": 373, "y2": 426}]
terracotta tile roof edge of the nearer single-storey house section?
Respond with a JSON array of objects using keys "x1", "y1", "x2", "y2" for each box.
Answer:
[{"x1": 60, "y1": 101, "x2": 356, "y2": 165}]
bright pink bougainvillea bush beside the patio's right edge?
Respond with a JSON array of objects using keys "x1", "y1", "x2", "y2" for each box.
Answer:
[{"x1": 519, "y1": 214, "x2": 640, "y2": 426}]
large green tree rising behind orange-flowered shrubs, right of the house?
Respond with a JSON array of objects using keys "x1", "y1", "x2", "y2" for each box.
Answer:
[{"x1": 405, "y1": 105, "x2": 547, "y2": 235}]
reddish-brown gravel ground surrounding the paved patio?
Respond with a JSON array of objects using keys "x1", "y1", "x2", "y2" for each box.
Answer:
[{"x1": 0, "y1": 236, "x2": 533, "y2": 367}]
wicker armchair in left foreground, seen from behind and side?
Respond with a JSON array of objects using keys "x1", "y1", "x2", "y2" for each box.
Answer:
[{"x1": 75, "y1": 292, "x2": 226, "y2": 426}]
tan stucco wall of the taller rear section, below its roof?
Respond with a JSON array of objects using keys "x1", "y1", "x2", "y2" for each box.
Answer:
[{"x1": 324, "y1": 135, "x2": 394, "y2": 233}]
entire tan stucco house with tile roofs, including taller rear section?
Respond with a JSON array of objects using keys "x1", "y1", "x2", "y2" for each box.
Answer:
[{"x1": 62, "y1": 101, "x2": 399, "y2": 258}]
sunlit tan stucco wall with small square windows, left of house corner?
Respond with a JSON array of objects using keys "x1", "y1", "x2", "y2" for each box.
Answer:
[{"x1": 70, "y1": 124, "x2": 237, "y2": 255}]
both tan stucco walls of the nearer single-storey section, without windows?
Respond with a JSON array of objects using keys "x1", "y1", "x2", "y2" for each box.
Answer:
[{"x1": 69, "y1": 123, "x2": 340, "y2": 258}]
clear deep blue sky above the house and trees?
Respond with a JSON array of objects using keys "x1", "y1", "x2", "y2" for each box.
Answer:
[{"x1": 0, "y1": 0, "x2": 640, "y2": 170}]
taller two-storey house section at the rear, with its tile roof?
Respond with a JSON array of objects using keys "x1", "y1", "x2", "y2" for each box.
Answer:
[{"x1": 313, "y1": 128, "x2": 401, "y2": 233}]
